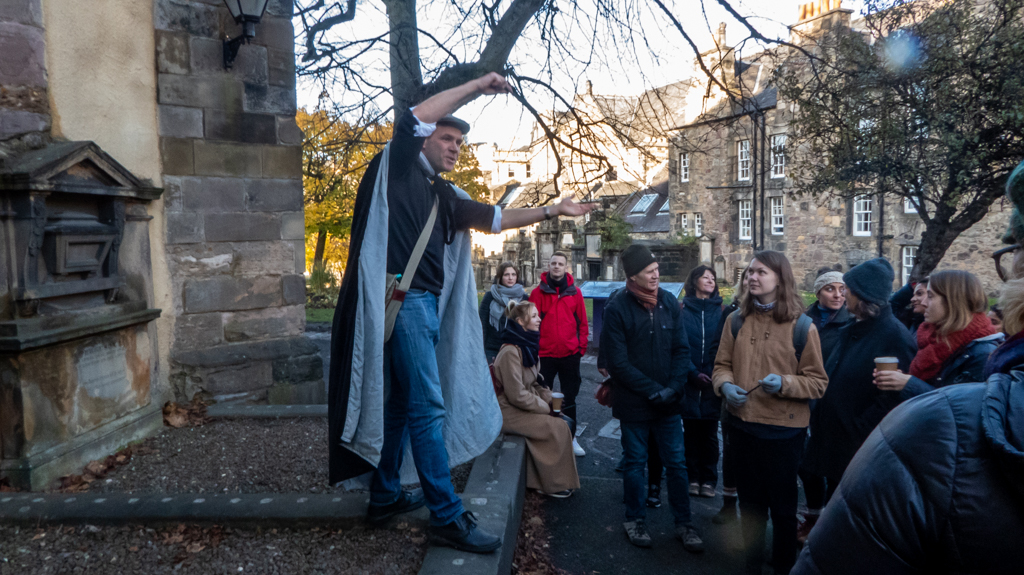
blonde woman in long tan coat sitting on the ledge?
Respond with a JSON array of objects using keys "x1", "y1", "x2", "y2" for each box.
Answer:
[{"x1": 494, "y1": 301, "x2": 580, "y2": 498}]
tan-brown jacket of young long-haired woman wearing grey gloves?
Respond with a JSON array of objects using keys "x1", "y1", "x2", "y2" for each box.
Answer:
[{"x1": 712, "y1": 310, "x2": 828, "y2": 428}]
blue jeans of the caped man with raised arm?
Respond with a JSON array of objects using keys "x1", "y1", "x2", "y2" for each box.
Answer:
[{"x1": 370, "y1": 290, "x2": 465, "y2": 525}]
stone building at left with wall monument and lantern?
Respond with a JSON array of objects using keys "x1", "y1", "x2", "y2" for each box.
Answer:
[{"x1": 0, "y1": 0, "x2": 315, "y2": 488}]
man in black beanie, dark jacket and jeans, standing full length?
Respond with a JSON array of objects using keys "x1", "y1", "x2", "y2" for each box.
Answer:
[{"x1": 601, "y1": 245, "x2": 703, "y2": 552}]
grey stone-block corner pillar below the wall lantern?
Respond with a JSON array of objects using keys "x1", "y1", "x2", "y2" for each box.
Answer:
[{"x1": 155, "y1": 0, "x2": 317, "y2": 403}]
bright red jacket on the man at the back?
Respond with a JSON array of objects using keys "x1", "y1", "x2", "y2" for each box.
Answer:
[{"x1": 529, "y1": 272, "x2": 590, "y2": 357}]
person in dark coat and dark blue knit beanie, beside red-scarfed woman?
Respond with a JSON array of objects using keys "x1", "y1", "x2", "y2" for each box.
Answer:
[{"x1": 803, "y1": 258, "x2": 918, "y2": 499}]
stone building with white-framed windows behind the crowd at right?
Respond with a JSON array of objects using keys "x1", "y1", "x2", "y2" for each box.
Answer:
[{"x1": 669, "y1": 3, "x2": 1010, "y2": 293}]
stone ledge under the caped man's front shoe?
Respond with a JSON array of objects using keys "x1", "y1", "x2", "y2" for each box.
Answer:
[{"x1": 420, "y1": 436, "x2": 526, "y2": 575}]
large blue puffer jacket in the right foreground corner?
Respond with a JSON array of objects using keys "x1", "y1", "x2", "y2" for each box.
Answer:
[{"x1": 792, "y1": 335, "x2": 1024, "y2": 575}]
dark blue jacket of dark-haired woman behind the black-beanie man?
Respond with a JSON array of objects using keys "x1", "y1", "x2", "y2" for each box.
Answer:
[{"x1": 682, "y1": 296, "x2": 723, "y2": 419}]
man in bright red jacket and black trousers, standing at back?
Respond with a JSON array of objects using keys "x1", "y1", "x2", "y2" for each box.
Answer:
[{"x1": 529, "y1": 252, "x2": 590, "y2": 456}]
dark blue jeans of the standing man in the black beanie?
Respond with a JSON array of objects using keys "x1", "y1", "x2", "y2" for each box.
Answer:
[{"x1": 620, "y1": 415, "x2": 690, "y2": 526}]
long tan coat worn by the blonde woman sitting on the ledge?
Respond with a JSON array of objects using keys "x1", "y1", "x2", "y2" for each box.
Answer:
[{"x1": 495, "y1": 345, "x2": 580, "y2": 493}]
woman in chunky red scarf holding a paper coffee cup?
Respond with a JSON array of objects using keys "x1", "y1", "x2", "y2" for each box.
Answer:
[{"x1": 874, "y1": 270, "x2": 1004, "y2": 399}]
